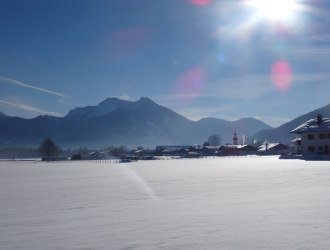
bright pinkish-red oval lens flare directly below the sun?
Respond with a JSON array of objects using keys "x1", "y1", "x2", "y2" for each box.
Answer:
[{"x1": 271, "y1": 61, "x2": 293, "y2": 92}]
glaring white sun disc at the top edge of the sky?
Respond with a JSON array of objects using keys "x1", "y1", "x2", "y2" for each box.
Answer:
[{"x1": 249, "y1": 0, "x2": 297, "y2": 21}]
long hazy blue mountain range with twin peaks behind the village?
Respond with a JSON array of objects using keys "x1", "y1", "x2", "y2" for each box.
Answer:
[{"x1": 0, "y1": 97, "x2": 271, "y2": 147}]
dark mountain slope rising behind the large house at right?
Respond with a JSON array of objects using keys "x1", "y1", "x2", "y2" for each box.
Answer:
[{"x1": 249, "y1": 104, "x2": 330, "y2": 144}]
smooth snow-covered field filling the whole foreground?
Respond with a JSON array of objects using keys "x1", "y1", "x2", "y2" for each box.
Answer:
[{"x1": 0, "y1": 157, "x2": 330, "y2": 249}]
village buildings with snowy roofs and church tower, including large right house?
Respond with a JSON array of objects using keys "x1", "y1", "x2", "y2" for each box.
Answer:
[{"x1": 64, "y1": 114, "x2": 330, "y2": 162}]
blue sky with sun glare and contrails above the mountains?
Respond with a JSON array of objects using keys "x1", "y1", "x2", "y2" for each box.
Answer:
[{"x1": 0, "y1": 0, "x2": 330, "y2": 127}]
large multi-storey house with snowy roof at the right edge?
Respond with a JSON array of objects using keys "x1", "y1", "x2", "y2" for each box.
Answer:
[{"x1": 290, "y1": 115, "x2": 330, "y2": 155}]
